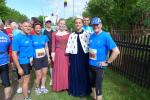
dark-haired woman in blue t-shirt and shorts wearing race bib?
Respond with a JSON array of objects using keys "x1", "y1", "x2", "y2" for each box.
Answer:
[{"x1": 32, "y1": 23, "x2": 50, "y2": 95}]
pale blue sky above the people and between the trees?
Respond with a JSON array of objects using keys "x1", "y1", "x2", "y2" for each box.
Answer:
[{"x1": 6, "y1": 0, "x2": 89, "y2": 18}]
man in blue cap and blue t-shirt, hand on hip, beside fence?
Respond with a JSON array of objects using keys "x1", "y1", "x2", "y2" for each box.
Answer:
[{"x1": 89, "y1": 17, "x2": 120, "y2": 100}]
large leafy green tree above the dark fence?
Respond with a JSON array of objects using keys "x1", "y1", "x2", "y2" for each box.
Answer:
[{"x1": 83, "y1": 0, "x2": 150, "y2": 28}]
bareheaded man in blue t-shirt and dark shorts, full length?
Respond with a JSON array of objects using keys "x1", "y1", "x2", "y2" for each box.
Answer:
[{"x1": 12, "y1": 21, "x2": 33, "y2": 100}]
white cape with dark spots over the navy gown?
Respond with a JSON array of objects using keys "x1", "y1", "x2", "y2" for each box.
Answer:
[{"x1": 66, "y1": 31, "x2": 90, "y2": 54}]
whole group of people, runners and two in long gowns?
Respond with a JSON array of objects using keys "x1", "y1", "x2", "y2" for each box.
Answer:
[{"x1": 0, "y1": 17, "x2": 120, "y2": 100}]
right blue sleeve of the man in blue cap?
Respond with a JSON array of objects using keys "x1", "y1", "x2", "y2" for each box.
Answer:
[{"x1": 106, "y1": 33, "x2": 117, "y2": 50}]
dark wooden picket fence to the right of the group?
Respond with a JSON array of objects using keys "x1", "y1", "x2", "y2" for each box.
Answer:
[{"x1": 112, "y1": 30, "x2": 150, "y2": 88}]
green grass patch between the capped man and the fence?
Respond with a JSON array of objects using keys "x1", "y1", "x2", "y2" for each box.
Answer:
[{"x1": 103, "y1": 70, "x2": 150, "y2": 100}]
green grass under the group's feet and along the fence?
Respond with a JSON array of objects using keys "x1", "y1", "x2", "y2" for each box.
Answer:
[{"x1": 15, "y1": 69, "x2": 150, "y2": 100}]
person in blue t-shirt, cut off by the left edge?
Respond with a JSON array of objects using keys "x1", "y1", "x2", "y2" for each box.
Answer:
[{"x1": 0, "y1": 30, "x2": 11, "y2": 100}]
